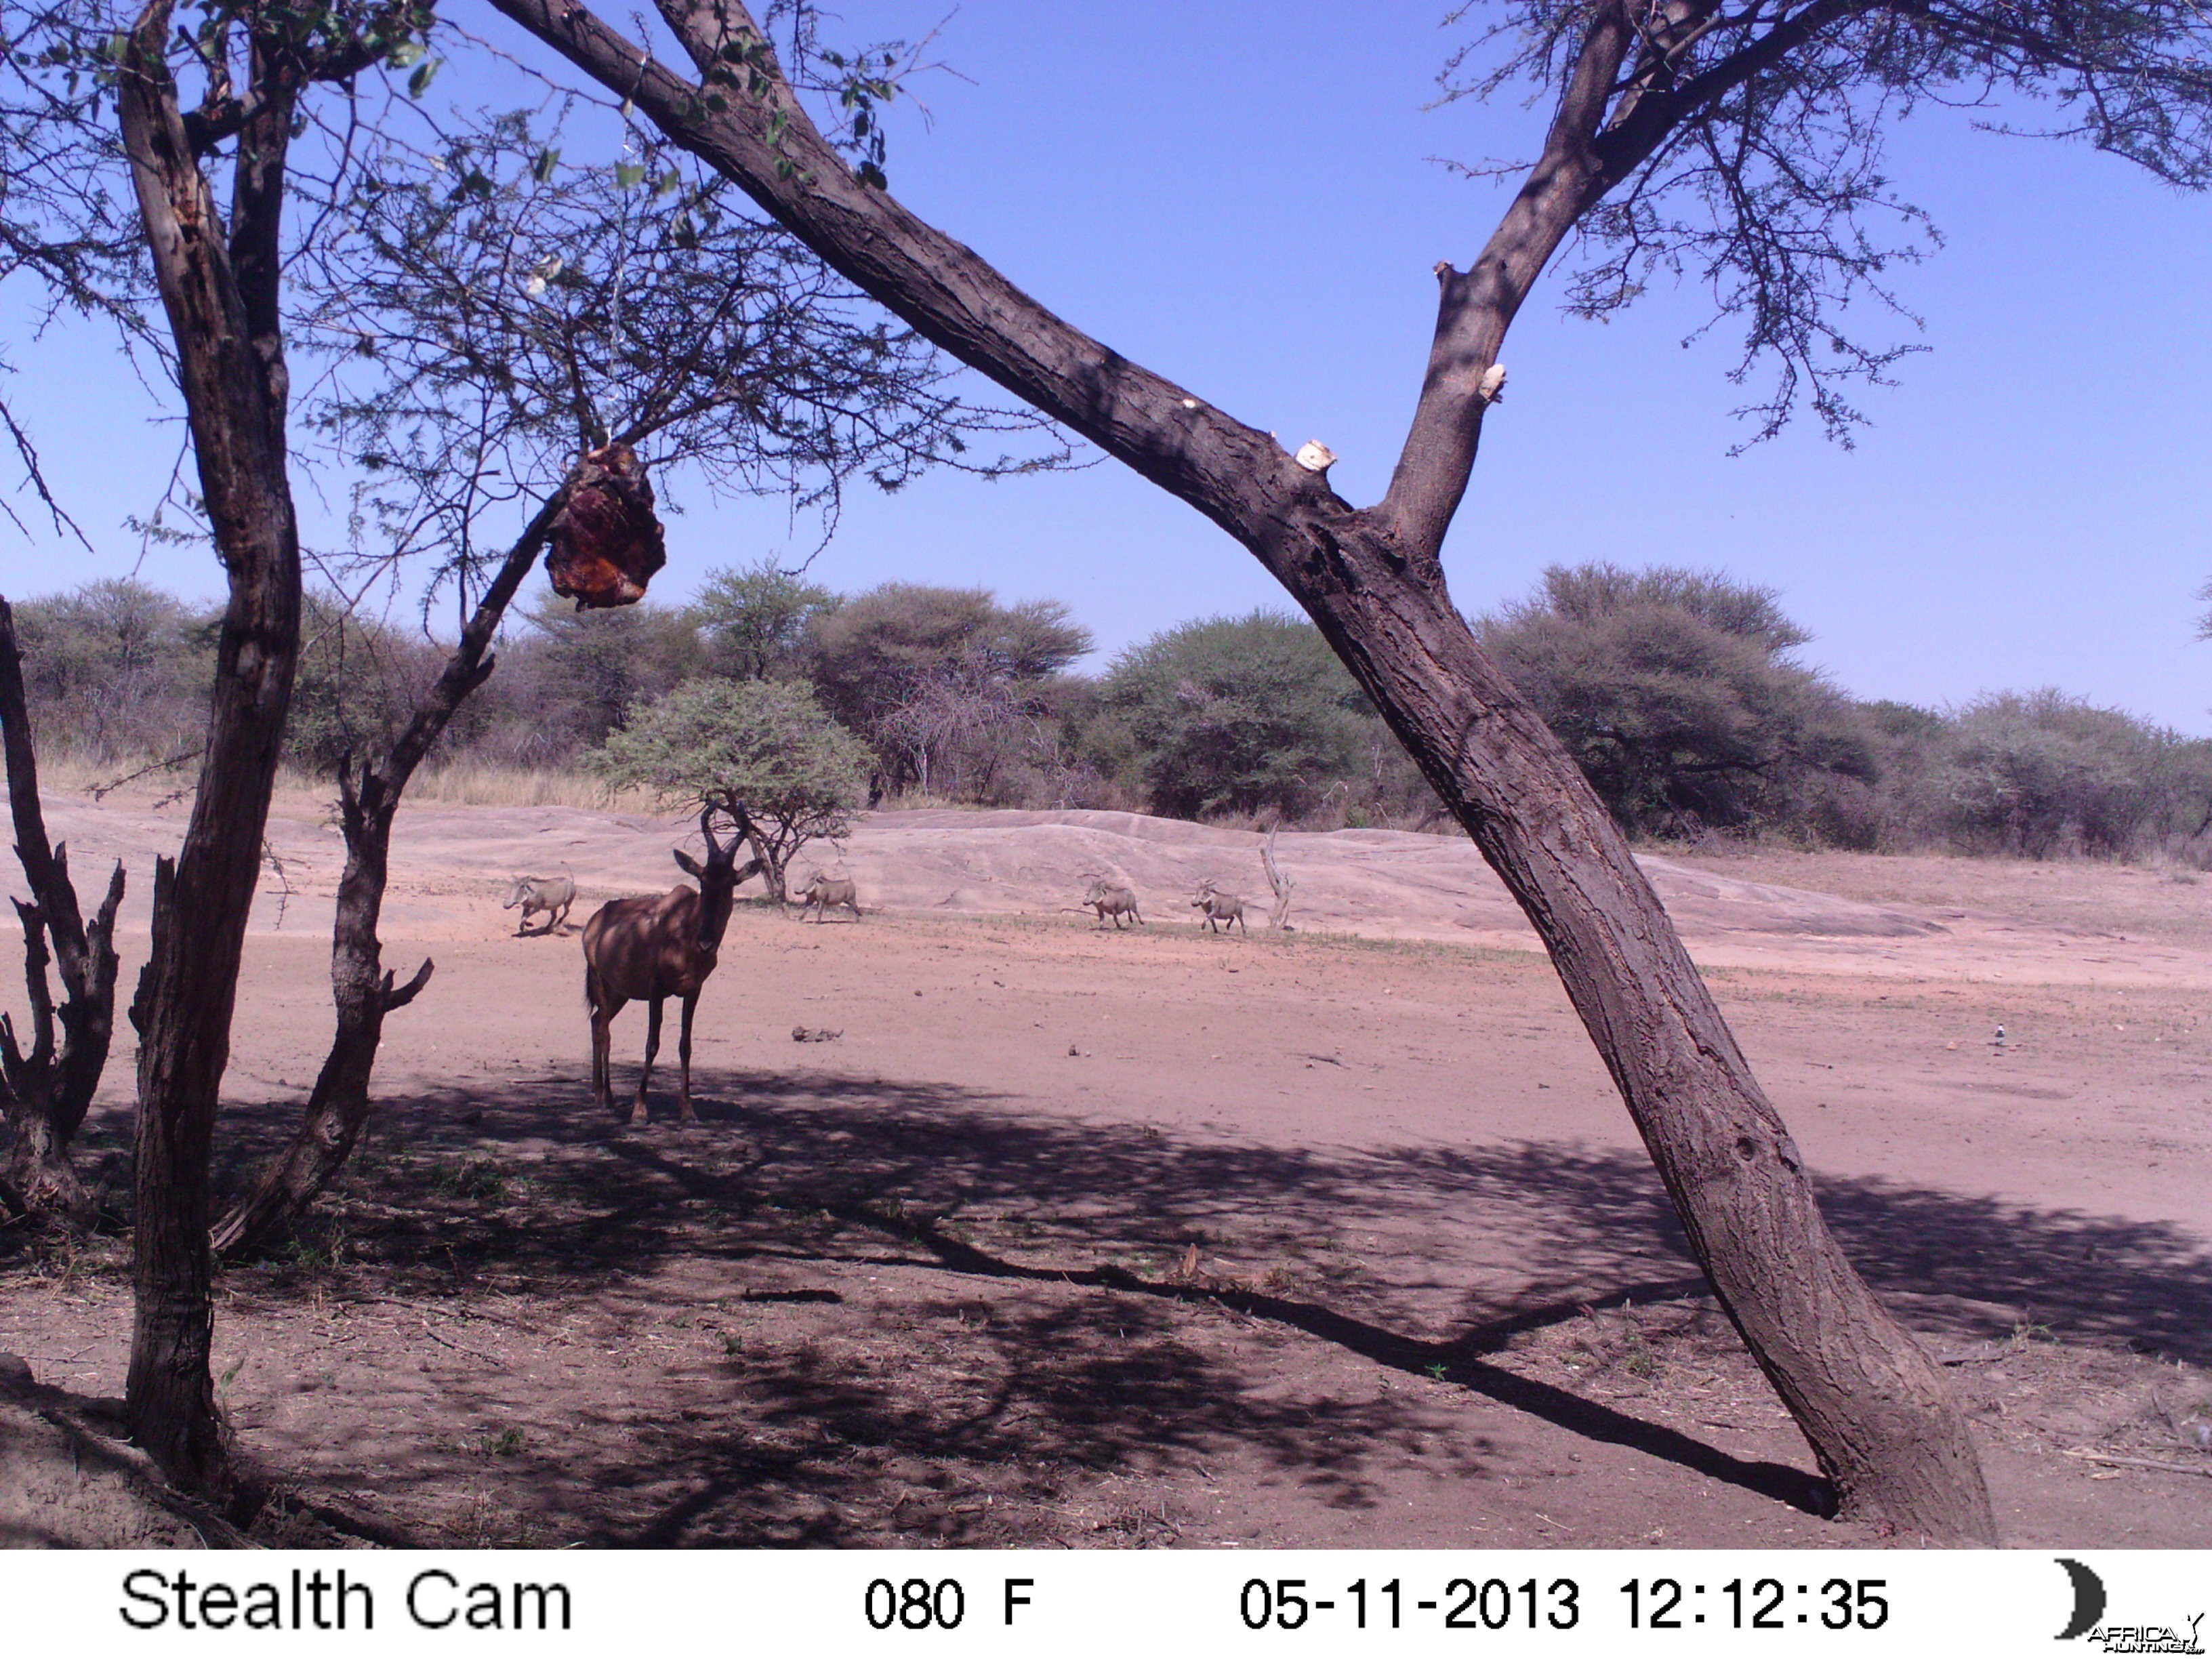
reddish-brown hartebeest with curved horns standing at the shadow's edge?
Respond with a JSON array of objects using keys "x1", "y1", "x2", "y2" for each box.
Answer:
[{"x1": 584, "y1": 807, "x2": 759, "y2": 1124}]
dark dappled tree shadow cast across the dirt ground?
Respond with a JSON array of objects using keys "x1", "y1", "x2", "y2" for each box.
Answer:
[{"x1": 194, "y1": 1071, "x2": 2212, "y2": 1544}]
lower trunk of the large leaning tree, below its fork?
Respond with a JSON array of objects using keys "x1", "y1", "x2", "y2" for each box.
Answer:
[{"x1": 1276, "y1": 513, "x2": 1995, "y2": 1542}]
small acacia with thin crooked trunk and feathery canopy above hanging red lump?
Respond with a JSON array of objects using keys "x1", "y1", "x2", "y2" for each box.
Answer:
[{"x1": 215, "y1": 112, "x2": 1048, "y2": 1254}]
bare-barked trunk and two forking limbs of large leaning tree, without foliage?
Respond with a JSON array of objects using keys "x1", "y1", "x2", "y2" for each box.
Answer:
[{"x1": 493, "y1": 0, "x2": 1995, "y2": 1542}]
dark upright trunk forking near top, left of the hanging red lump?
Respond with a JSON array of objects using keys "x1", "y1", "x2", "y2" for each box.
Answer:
[{"x1": 117, "y1": 0, "x2": 301, "y2": 1511}]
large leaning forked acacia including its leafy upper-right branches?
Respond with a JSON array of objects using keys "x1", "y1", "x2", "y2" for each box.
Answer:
[{"x1": 493, "y1": 0, "x2": 2212, "y2": 1542}]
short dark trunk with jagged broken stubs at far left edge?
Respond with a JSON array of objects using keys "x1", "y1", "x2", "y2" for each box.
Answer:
[{"x1": 0, "y1": 600, "x2": 124, "y2": 1225}]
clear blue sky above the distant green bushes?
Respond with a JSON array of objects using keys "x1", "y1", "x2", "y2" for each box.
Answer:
[{"x1": 0, "y1": 0, "x2": 2212, "y2": 732}]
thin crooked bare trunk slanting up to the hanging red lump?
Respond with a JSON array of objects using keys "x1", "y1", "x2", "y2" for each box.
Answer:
[{"x1": 212, "y1": 489, "x2": 569, "y2": 1256}]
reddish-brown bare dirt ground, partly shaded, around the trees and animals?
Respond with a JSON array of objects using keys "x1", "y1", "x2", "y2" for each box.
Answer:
[{"x1": 0, "y1": 798, "x2": 2212, "y2": 1549}]
